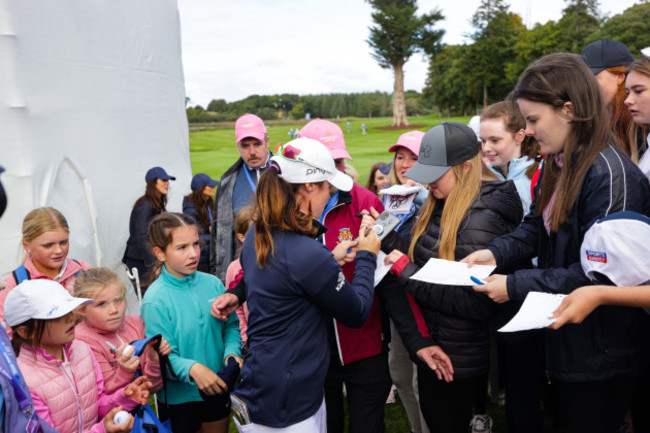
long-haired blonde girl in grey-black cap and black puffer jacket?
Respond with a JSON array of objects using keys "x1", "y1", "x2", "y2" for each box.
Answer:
[{"x1": 363, "y1": 123, "x2": 522, "y2": 433}]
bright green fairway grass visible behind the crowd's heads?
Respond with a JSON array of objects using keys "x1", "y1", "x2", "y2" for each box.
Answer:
[{"x1": 190, "y1": 114, "x2": 470, "y2": 185}]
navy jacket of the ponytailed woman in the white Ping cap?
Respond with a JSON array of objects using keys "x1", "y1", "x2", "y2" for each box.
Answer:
[{"x1": 235, "y1": 227, "x2": 376, "y2": 428}]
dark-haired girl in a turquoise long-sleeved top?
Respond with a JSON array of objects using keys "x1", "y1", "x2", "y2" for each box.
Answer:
[{"x1": 142, "y1": 213, "x2": 241, "y2": 433}]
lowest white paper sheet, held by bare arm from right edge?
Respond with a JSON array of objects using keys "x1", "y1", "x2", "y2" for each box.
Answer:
[{"x1": 499, "y1": 292, "x2": 566, "y2": 332}]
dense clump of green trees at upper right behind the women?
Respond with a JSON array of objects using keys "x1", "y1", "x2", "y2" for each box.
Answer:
[{"x1": 423, "y1": 0, "x2": 650, "y2": 115}]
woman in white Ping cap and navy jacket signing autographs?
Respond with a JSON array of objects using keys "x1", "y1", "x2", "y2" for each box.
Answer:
[{"x1": 230, "y1": 138, "x2": 380, "y2": 432}]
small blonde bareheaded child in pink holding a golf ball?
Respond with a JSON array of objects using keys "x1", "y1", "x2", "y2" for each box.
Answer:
[{"x1": 74, "y1": 268, "x2": 171, "y2": 393}]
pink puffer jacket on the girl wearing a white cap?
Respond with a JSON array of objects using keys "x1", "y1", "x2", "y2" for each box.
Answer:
[{"x1": 18, "y1": 340, "x2": 138, "y2": 433}]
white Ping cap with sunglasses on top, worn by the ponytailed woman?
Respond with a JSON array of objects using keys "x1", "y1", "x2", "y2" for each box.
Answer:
[{"x1": 271, "y1": 138, "x2": 354, "y2": 191}]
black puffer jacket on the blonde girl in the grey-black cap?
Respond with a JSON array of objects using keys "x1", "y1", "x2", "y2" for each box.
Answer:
[{"x1": 382, "y1": 181, "x2": 523, "y2": 378}]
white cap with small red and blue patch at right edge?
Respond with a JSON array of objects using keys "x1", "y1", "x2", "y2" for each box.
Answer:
[{"x1": 580, "y1": 211, "x2": 650, "y2": 286}]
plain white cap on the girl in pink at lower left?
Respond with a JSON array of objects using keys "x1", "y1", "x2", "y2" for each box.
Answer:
[{"x1": 5, "y1": 280, "x2": 95, "y2": 326}]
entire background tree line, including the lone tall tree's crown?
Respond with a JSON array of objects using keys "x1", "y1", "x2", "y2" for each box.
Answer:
[{"x1": 187, "y1": 0, "x2": 650, "y2": 123}]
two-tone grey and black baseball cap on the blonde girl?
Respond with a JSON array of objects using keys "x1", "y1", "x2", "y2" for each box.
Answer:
[{"x1": 404, "y1": 122, "x2": 478, "y2": 184}]
